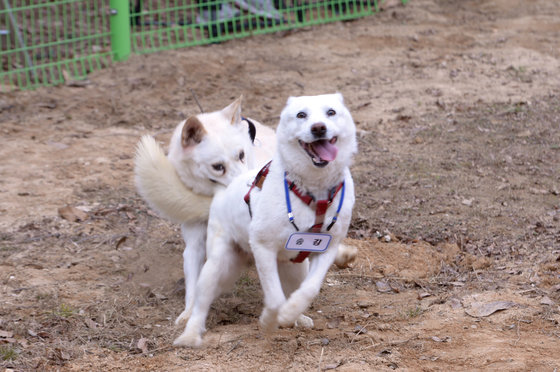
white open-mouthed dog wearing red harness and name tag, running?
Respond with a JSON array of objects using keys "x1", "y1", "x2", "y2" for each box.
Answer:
[{"x1": 174, "y1": 94, "x2": 357, "y2": 346}]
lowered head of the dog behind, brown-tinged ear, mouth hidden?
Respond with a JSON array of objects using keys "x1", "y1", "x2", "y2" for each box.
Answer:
[{"x1": 169, "y1": 97, "x2": 253, "y2": 195}]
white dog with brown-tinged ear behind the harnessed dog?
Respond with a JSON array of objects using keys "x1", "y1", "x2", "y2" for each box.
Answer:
[{"x1": 135, "y1": 97, "x2": 276, "y2": 323}]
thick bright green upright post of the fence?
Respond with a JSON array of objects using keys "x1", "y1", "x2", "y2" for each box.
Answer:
[{"x1": 109, "y1": 0, "x2": 130, "y2": 61}]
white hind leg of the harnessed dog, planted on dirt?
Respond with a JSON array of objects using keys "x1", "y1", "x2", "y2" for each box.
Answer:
[{"x1": 173, "y1": 235, "x2": 246, "y2": 347}]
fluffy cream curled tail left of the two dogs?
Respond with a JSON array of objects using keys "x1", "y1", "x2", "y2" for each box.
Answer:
[{"x1": 134, "y1": 135, "x2": 212, "y2": 224}]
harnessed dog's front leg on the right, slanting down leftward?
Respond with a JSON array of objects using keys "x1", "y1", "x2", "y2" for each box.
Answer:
[{"x1": 278, "y1": 242, "x2": 338, "y2": 327}]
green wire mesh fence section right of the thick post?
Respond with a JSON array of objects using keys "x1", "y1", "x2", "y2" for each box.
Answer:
[{"x1": 131, "y1": 0, "x2": 384, "y2": 53}]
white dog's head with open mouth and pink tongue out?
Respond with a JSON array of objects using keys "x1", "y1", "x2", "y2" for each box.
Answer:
[{"x1": 277, "y1": 93, "x2": 357, "y2": 173}]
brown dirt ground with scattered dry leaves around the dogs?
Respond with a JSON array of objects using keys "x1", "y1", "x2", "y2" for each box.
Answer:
[{"x1": 0, "y1": 0, "x2": 560, "y2": 371}]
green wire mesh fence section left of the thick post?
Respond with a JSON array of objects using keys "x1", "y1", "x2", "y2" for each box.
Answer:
[{"x1": 0, "y1": 0, "x2": 112, "y2": 90}]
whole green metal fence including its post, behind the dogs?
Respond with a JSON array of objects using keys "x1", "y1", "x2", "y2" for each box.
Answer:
[{"x1": 0, "y1": 0, "x2": 408, "y2": 91}]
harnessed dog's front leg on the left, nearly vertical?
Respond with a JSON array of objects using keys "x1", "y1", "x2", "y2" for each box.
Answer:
[{"x1": 253, "y1": 244, "x2": 286, "y2": 332}]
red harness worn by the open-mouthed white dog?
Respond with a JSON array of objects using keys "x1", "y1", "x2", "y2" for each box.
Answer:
[{"x1": 244, "y1": 162, "x2": 345, "y2": 263}]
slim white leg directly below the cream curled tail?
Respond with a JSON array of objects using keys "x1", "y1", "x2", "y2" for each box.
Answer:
[{"x1": 175, "y1": 223, "x2": 206, "y2": 325}]
